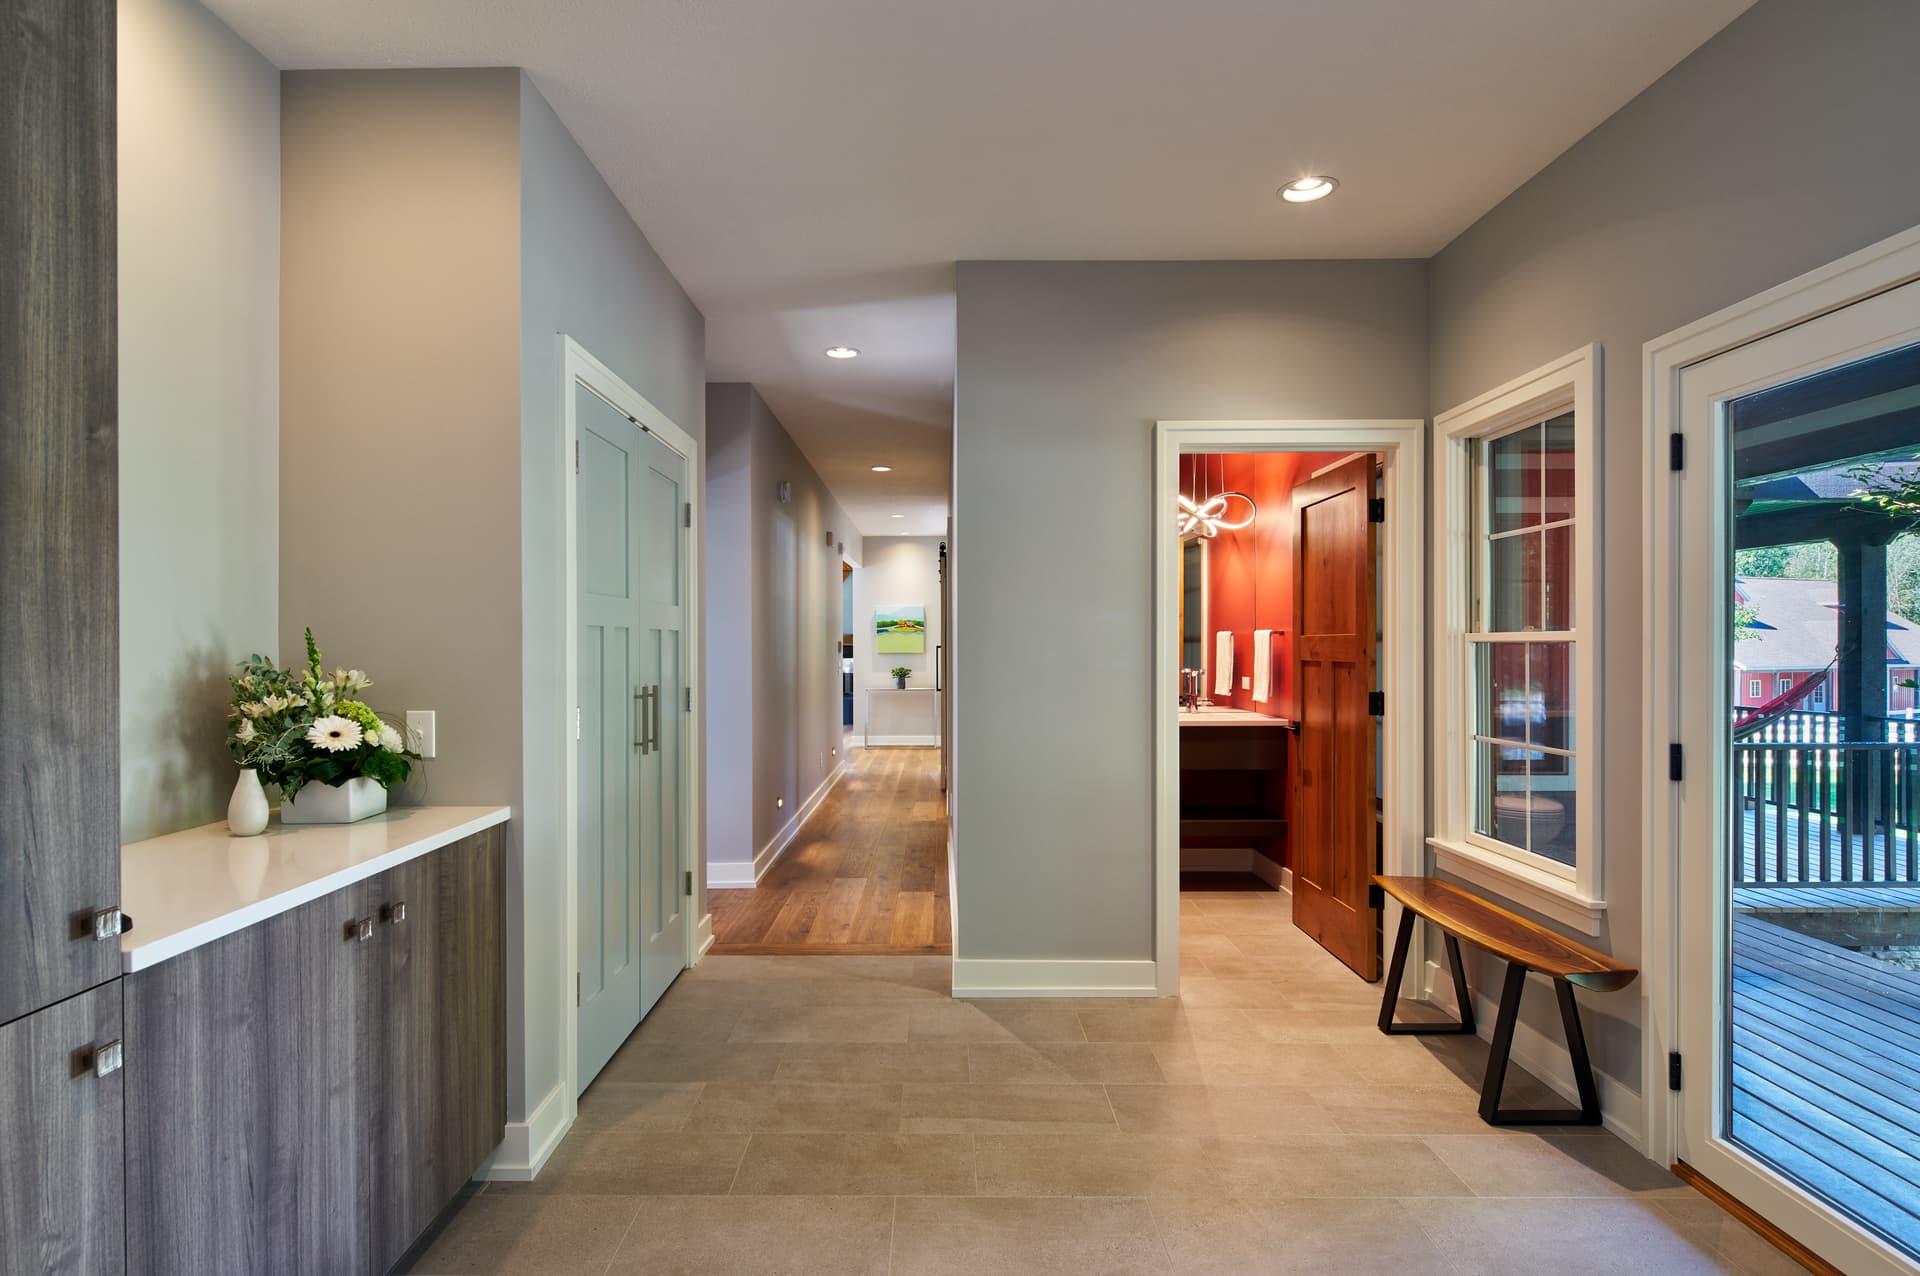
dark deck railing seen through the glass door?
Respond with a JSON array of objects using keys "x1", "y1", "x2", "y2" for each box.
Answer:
[{"x1": 1734, "y1": 714, "x2": 1920, "y2": 886}]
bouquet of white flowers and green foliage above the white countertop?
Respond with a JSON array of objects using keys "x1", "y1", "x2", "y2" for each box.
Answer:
[{"x1": 227, "y1": 629, "x2": 420, "y2": 800}]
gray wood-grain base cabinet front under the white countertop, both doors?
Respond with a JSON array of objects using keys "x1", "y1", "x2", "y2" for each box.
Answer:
[{"x1": 125, "y1": 827, "x2": 507, "y2": 1276}]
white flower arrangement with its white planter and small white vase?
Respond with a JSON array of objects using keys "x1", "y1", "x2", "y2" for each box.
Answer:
[{"x1": 227, "y1": 629, "x2": 420, "y2": 833}]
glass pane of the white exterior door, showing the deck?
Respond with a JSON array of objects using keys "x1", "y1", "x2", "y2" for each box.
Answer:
[{"x1": 1718, "y1": 333, "x2": 1920, "y2": 1255}]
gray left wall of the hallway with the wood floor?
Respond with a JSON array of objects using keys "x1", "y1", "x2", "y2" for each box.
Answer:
[{"x1": 707, "y1": 384, "x2": 860, "y2": 873}]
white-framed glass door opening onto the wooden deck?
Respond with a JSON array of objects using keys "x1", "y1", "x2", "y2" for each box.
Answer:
[{"x1": 1674, "y1": 274, "x2": 1920, "y2": 1272}]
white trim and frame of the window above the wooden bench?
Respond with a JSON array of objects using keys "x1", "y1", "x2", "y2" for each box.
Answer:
[{"x1": 1427, "y1": 345, "x2": 1607, "y2": 934}]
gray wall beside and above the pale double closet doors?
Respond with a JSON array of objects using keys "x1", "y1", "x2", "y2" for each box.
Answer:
[{"x1": 518, "y1": 73, "x2": 707, "y2": 1117}]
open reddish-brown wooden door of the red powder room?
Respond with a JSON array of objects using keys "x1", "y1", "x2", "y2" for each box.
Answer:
[{"x1": 1292, "y1": 457, "x2": 1380, "y2": 981}]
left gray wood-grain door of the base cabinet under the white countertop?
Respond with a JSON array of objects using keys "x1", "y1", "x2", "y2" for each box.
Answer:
[{"x1": 125, "y1": 879, "x2": 384, "y2": 1276}]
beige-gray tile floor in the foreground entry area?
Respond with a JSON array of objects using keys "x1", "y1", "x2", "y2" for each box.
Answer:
[{"x1": 401, "y1": 892, "x2": 1799, "y2": 1276}]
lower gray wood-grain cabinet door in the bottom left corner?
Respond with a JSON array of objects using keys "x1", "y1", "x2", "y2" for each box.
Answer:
[{"x1": 0, "y1": 981, "x2": 127, "y2": 1276}]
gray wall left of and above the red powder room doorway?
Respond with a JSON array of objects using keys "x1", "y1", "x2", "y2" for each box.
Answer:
[{"x1": 952, "y1": 261, "x2": 1428, "y2": 959}]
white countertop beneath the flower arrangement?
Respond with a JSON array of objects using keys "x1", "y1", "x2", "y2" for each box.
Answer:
[{"x1": 121, "y1": 806, "x2": 513, "y2": 973}]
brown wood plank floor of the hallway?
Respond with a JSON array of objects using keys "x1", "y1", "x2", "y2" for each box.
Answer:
[{"x1": 707, "y1": 748, "x2": 952, "y2": 956}]
